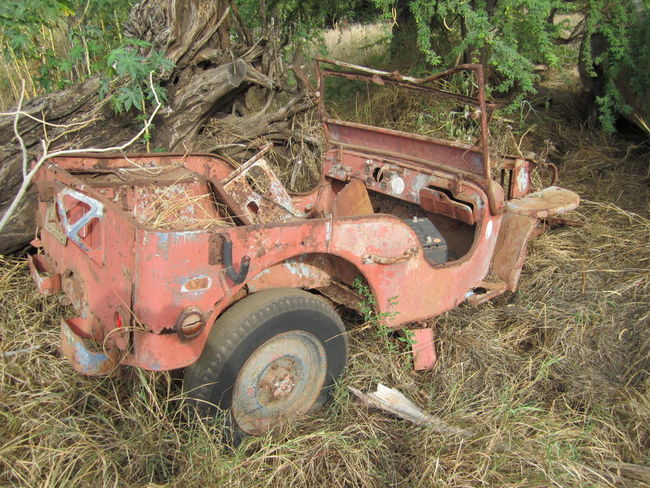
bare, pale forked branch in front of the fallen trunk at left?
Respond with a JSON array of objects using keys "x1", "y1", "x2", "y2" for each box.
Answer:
[{"x1": 0, "y1": 72, "x2": 162, "y2": 232}]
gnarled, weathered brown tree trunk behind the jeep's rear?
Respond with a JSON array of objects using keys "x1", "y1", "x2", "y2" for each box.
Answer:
[{"x1": 0, "y1": 0, "x2": 312, "y2": 253}]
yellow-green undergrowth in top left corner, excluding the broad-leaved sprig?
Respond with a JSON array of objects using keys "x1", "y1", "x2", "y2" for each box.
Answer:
[{"x1": 0, "y1": 0, "x2": 135, "y2": 105}]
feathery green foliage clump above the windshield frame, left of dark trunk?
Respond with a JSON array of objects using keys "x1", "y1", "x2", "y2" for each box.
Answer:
[{"x1": 377, "y1": 0, "x2": 567, "y2": 104}]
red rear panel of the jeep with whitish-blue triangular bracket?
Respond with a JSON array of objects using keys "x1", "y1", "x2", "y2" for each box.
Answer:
[{"x1": 36, "y1": 157, "x2": 135, "y2": 350}]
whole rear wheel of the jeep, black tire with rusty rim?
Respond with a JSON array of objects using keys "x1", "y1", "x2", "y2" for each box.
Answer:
[{"x1": 183, "y1": 288, "x2": 348, "y2": 438}]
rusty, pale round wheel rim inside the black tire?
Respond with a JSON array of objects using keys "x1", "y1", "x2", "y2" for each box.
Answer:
[{"x1": 231, "y1": 330, "x2": 327, "y2": 435}]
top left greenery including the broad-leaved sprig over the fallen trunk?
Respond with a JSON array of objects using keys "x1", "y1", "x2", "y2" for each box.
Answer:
[{"x1": 0, "y1": 0, "x2": 173, "y2": 118}]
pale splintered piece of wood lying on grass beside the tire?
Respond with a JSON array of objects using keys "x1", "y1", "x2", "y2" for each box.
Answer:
[{"x1": 348, "y1": 383, "x2": 474, "y2": 439}]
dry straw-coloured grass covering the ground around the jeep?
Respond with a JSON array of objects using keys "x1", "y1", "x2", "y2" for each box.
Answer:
[{"x1": 0, "y1": 66, "x2": 650, "y2": 488}]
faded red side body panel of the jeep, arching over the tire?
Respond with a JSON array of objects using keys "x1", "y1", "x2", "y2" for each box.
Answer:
[{"x1": 125, "y1": 207, "x2": 498, "y2": 369}]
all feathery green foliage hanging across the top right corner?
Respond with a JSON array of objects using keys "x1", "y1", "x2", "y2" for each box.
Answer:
[{"x1": 375, "y1": 0, "x2": 650, "y2": 132}]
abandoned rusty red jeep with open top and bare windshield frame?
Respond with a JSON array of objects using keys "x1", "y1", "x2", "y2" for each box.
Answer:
[{"x1": 29, "y1": 60, "x2": 579, "y2": 434}]
